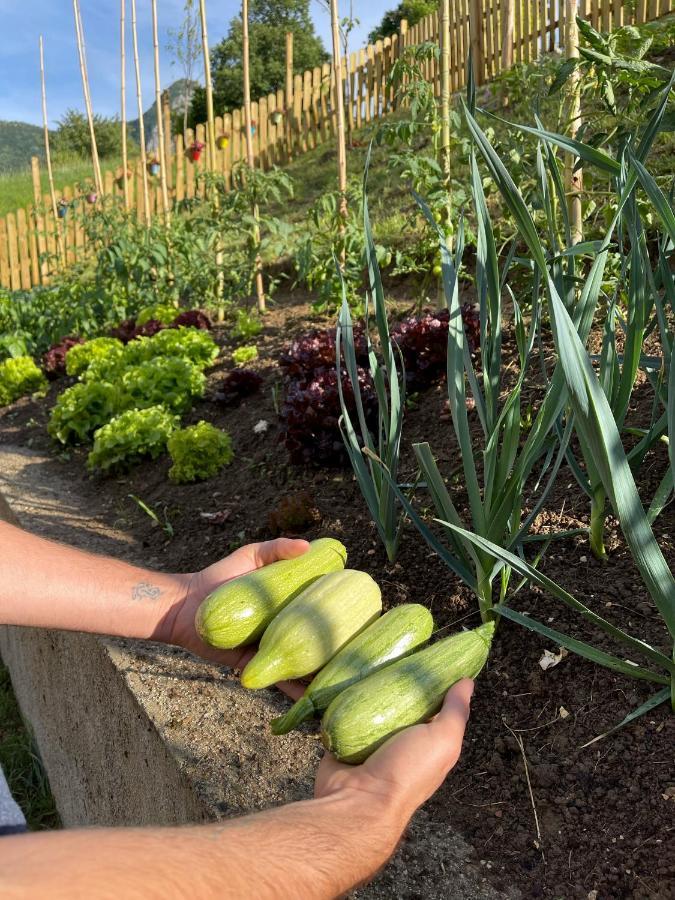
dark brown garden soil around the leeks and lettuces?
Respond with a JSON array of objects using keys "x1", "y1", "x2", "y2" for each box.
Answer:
[{"x1": 0, "y1": 294, "x2": 675, "y2": 900}]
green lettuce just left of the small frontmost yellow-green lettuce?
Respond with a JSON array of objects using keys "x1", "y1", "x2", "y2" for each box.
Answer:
[{"x1": 87, "y1": 406, "x2": 179, "y2": 472}]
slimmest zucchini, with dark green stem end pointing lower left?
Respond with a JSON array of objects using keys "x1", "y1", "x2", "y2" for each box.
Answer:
[{"x1": 272, "y1": 603, "x2": 434, "y2": 734}]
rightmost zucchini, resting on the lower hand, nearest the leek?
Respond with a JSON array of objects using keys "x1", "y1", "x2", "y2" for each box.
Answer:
[{"x1": 321, "y1": 622, "x2": 495, "y2": 763}]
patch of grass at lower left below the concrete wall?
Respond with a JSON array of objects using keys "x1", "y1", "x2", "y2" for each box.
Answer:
[{"x1": 0, "y1": 664, "x2": 60, "y2": 831}]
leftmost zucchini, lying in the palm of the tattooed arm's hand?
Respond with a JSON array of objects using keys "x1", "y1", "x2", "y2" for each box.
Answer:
[{"x1": 195, "y1": 538, "x2": 347, "y2": 650}]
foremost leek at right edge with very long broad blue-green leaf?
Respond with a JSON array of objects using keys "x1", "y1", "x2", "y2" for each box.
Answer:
[{"x1": 443, "y1": 92, "x2": 675, "y2": 727}]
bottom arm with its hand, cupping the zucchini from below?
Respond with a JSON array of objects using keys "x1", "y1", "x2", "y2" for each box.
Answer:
[{"x1": 0, "y1": 680, "x2": 473, "y2": 900}]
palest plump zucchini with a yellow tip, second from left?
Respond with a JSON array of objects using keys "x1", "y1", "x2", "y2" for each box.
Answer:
[{"x1": 241, "y1": 569, "x2": 382, "y2": 690}]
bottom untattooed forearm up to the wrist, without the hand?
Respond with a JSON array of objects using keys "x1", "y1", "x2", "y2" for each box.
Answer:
[{"x1": 0, "y1": 791, "x2": 407, "y2": 900}]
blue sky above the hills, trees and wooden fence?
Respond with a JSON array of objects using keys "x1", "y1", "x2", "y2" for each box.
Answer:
[{"x1": 0, "y1": 0, "x2": 390, "y2": 126}]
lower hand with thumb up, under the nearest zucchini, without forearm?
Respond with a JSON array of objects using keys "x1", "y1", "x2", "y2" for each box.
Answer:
[{"x1": 314, "y1": 678, "x2": 473, "y2": 822}]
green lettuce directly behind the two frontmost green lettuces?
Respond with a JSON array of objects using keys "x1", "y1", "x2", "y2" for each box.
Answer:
[{"x1": 119, "y1": 357, "x2": 206, "y2": 413}]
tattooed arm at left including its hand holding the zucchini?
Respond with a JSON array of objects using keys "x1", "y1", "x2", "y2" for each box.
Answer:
[{"x1": 0, "y1": 522, "x2": 309, "y2": 667}]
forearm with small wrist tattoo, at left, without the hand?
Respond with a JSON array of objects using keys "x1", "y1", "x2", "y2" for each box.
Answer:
[{"x1": 0, "y1": 522, "x2": 189, "y2": 638}]
